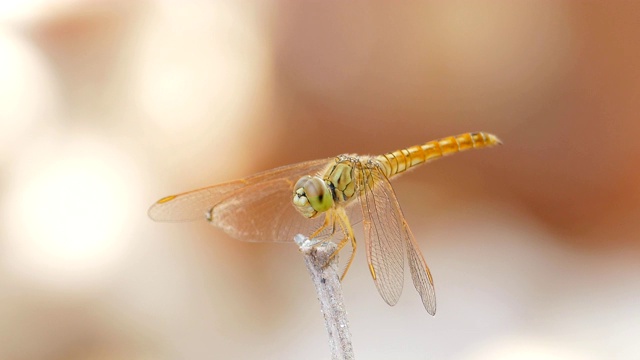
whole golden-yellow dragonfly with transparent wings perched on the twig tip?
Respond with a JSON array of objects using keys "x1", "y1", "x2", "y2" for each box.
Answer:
[{"x1": 148, "y1": 132, "x2": 501, "y2": 315}]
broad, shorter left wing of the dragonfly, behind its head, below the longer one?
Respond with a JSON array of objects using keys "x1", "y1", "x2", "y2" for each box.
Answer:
[{"x1": 210, "y1": 178, "x2": 324, "y2": 242}]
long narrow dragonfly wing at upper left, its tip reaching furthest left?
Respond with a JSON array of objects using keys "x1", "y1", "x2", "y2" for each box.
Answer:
[{"x1": 149, "y1": 158, "x2": 331, "y2": 221}]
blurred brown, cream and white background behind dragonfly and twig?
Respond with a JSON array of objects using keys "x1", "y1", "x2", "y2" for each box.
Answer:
[{"x1": 0, "y1": 0, "x2": 640, "y2": 360}]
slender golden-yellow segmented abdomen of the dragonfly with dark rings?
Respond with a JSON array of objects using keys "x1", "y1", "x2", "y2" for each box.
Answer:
[{"x1": 377, "y1": 132, "x2": 501, "y2": 177}]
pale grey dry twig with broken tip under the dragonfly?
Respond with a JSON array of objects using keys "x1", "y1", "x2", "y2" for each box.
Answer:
[{"x1": 294, "y1": 235, "x2": 354, "y2": 360}]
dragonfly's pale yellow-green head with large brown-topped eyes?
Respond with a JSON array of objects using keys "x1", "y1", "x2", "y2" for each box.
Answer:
[{"x1": 293, "y1": 175, "x2": 333, "y2": 218}]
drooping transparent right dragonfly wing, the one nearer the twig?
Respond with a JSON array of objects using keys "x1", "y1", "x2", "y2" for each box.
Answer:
[{"x1": 360, "y1": 167, "x2": 405, "y2": 305}]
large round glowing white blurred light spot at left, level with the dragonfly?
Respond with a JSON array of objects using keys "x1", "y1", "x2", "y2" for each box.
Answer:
[{"x1": 2, "y1": 138, "x2": 136, "y2": 287}]
